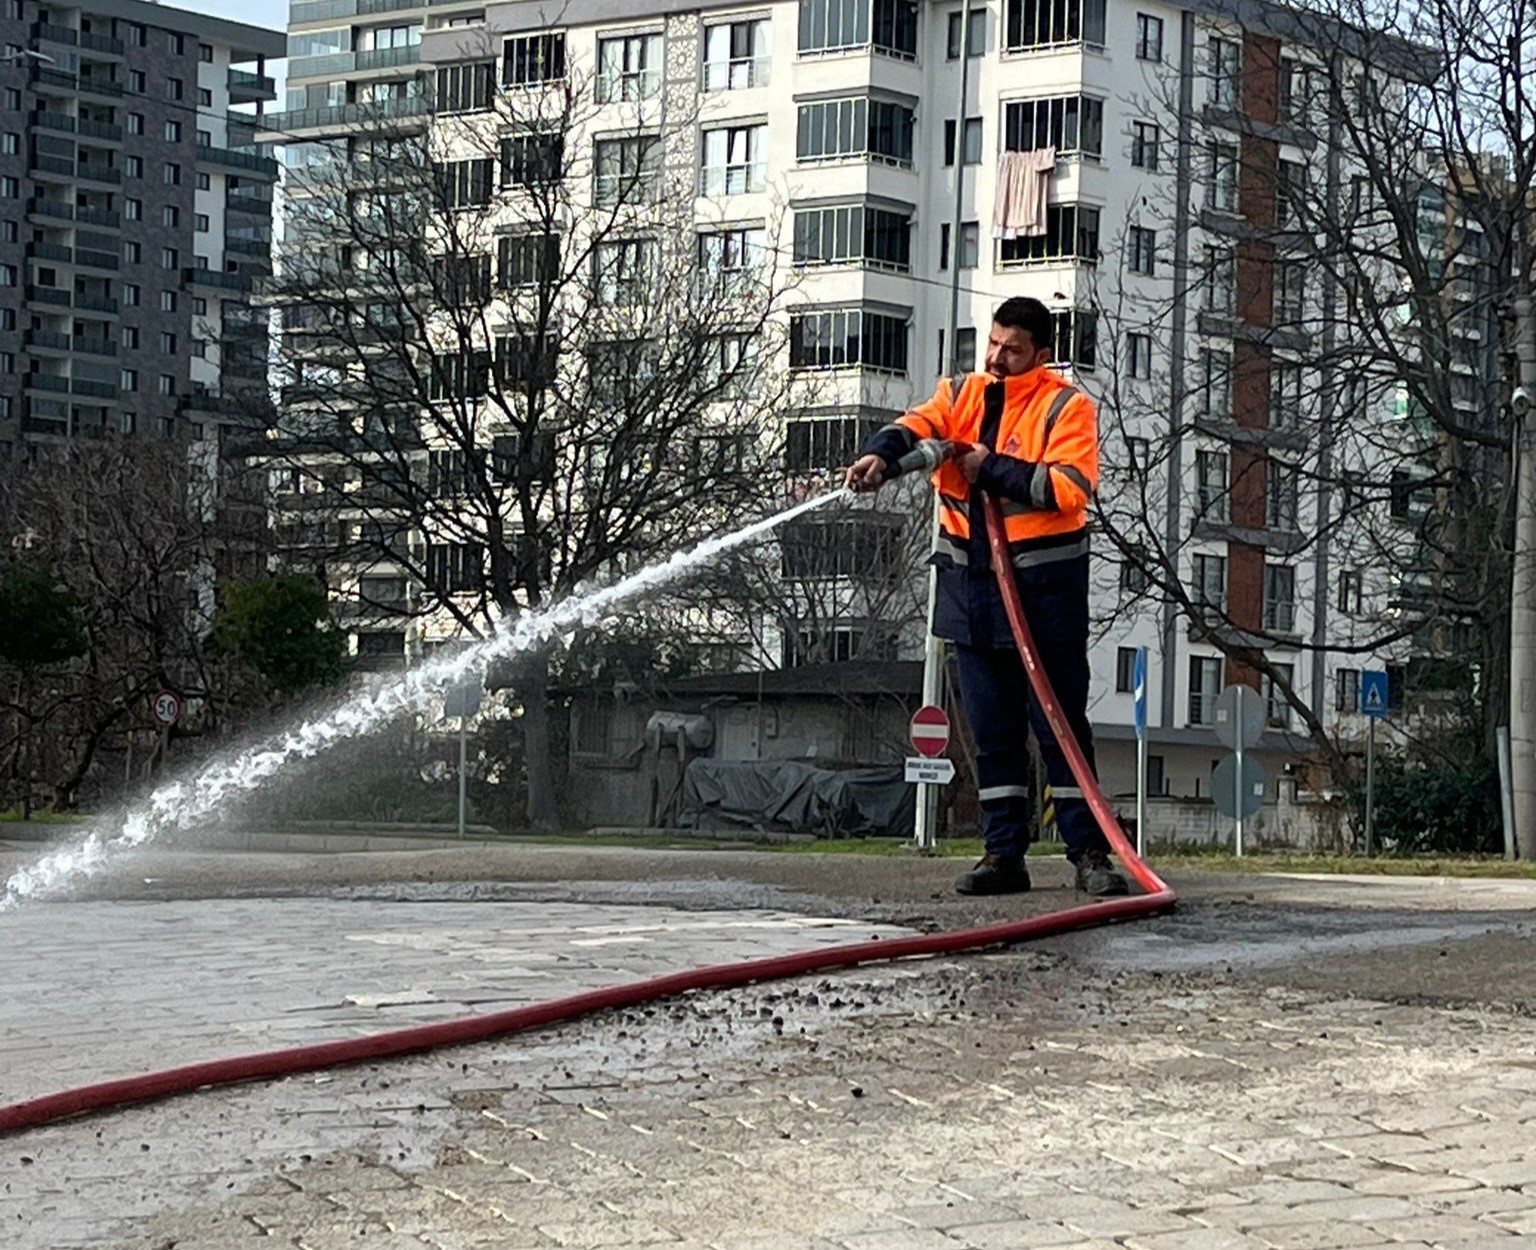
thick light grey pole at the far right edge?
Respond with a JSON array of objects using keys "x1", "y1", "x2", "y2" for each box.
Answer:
[{"x1": 1510, "y1": 293, "x2": 1536, "y2": 860}]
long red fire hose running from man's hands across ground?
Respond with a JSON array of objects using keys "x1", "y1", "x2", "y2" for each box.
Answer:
[{"x1": 0, "y1": 499, "x2": 1175, "y2": 1133}]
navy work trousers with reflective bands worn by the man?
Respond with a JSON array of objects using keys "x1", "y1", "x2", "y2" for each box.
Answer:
[{"x1": 955, "y1": 571, "x2": 1109, "y2": 863}]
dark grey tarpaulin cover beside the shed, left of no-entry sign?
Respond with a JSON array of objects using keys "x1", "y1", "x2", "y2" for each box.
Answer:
[{"x1": 684, "y1": 760, "x2": 912, "y2": 837}]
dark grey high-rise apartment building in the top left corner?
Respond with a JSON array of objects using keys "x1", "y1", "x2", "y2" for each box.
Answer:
[{"x1": 0, "y1": 0, "x2": 286, "y2": 448}]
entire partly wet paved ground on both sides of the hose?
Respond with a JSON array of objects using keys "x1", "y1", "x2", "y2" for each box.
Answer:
[{"x1": 0, "y1": 848, "x2": 1536, "y2": 1250}]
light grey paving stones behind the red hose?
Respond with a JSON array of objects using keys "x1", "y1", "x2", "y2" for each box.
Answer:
[{"x1": 0, "y1": 898, "x2": 905, "y2": 1101}]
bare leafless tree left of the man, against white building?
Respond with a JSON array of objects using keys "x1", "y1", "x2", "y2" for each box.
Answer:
[{"x1": 272, "y1": 48, "x2": 811, "y2": 826}]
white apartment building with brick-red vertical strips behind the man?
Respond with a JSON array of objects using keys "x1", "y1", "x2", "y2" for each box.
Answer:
[{"x1": 279, "y1": 0, "x2": 1425, "y2": 794}]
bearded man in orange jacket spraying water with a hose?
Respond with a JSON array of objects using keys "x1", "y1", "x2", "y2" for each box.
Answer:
[{"x1": 846, "y1": 298, "x2": 1127, "y2": 897}]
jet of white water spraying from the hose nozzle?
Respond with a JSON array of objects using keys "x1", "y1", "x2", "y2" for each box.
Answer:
[{"x1": 0, "y1": 490, "x2": 846, "y2": 912}]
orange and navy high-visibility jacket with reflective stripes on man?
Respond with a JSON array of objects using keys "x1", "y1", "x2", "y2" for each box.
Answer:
[{"x1": 868, "y1": 367, "x2": 1098, "y2": 568}]
